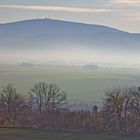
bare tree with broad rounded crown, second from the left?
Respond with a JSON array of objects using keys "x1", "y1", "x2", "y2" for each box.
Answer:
[{"x1": 29, "y1": 82, "x2": 66, "y2": 125}]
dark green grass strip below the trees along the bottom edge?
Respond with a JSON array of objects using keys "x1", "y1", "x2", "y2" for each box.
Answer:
[{"x1": 0, "y1": 128, "x2": 140, "y2": 140}]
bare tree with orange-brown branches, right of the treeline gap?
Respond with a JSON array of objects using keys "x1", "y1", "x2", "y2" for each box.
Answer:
[{"x1": 104, "y1": 87, "x2": 136, "y2": 133}]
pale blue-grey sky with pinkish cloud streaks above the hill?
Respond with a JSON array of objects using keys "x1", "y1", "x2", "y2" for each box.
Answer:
[{"x1": 0, "y1": 0, "x2": 140, "y2": 32}]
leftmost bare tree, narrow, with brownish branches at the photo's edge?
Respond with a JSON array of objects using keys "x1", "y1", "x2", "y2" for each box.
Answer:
[{"x1": 0, "y1": 84, "x2": 26, "y2": 125}]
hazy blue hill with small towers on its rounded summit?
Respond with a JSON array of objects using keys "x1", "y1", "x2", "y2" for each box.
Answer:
[{"x1": 0, "y1": 19, "x2": 140, "y2": 63}]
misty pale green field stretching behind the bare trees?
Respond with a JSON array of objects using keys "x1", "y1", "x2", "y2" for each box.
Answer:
[{"x1": 0, "y1": 66, "x2": 140, "y2": 101}]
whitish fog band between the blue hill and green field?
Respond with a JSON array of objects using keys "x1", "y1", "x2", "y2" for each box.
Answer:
[{"x1": 0, "y1": 48, "x2": 140, "y2": 65}]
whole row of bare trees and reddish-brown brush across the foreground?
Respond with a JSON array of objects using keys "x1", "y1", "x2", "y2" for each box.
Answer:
[{"x1": 0, "y1": 82, "x2": 140, "y2": 134}]
